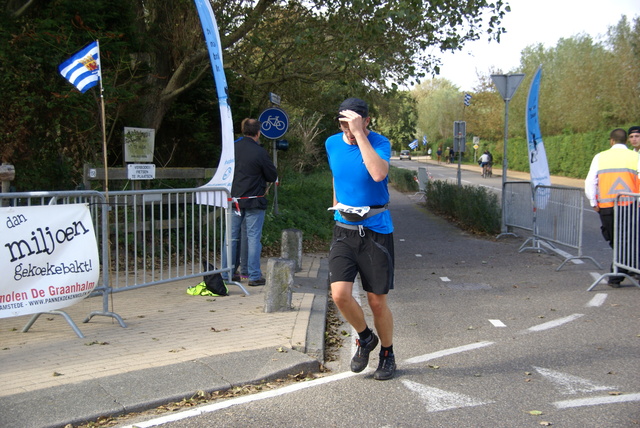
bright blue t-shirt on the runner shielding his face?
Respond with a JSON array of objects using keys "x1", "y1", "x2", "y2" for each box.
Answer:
[{"x1": 325, "y1": 131, "x2": 393, "y2": 233}]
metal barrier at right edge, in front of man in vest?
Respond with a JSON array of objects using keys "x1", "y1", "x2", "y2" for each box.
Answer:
[{"x1": 587, "y1": 193, "x2": 640, "y2": 291}]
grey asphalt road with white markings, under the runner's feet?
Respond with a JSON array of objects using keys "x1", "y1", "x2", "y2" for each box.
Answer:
[{"x1": 124, "y1": 173, "x2": 640, "y2": 428}]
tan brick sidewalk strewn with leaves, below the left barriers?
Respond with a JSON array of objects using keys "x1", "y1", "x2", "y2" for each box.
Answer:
[{"x1": 0, "y1": 255, "x2": 323, "y2": 397}]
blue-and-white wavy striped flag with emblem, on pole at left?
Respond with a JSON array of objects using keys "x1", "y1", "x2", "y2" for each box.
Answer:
[{"x1": 58, "y1": 40, "x2": 102, "y2": 94}]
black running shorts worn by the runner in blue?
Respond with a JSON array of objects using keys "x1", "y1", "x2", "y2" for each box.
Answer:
[{"x1": 329, "y1": 225, "x2": 394, "y2": 294}]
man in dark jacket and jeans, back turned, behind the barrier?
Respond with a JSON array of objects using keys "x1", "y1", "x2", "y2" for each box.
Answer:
[{"x1": 222, "y1": 119, "x2": 278, "y2": 287}]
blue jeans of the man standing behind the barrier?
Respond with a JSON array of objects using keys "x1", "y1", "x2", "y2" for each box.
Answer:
[{"x1": 222, "y1": 208, "x2": 266, "y2": 281}]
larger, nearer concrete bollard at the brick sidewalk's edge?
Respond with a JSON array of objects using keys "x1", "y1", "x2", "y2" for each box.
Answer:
[{"x1": 264, "y1": 258, "x2": 295, "y2": 313}]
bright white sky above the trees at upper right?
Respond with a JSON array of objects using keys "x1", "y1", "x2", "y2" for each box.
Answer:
[{"x1": 432, "y1": 0, "x2": 640, "y2": 91}]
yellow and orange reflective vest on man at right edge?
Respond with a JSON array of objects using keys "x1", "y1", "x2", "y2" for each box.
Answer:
[{"x1": 597, "y1": 149, "x2": 640, "y2": 208}]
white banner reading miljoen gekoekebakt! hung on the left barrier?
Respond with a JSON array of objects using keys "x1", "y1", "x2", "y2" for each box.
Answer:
[{"x1": 0, "y1": 204, "x2": 100, "y2": 318}]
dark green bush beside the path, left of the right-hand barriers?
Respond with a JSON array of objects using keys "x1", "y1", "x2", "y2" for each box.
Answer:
[{"x1": 426, "y1": 180, "x2": 500, "y2": 235}]
